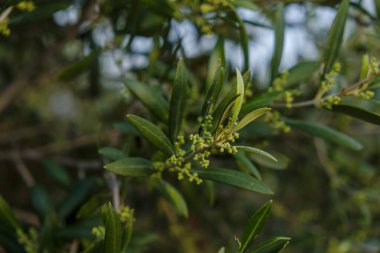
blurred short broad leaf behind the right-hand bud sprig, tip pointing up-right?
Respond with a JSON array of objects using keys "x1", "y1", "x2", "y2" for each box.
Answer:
[{"x1": 285, "y1": 61, "x2": 320, "y2": 88}]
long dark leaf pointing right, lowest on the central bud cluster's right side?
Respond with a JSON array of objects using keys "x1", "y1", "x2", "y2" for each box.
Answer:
[{"x1": 192, "y1": 168, "x2": 273, "y2": 194}]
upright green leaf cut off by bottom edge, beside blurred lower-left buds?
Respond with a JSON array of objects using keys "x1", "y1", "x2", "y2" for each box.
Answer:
[{"x1": 103, "y1": 203, "x2": 121, "y2": 253}]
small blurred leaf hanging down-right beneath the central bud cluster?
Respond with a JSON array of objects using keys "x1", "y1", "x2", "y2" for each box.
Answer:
[{"x1": 158, "y1": 180, "x2": 189, "y2": 218}]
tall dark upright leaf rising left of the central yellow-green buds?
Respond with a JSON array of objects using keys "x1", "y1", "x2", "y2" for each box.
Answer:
[{"x1": 169, "y1": 58, "x2": 188, "y2": 143}]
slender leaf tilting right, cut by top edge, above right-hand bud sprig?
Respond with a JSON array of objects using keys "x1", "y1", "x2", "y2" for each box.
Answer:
[{"x1": 322, "y1": 0, "x2": 350, "y2": 74}]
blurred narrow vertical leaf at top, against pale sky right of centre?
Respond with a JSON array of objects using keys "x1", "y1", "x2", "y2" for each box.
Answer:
[{"x1": 271, "y1": 3, "x2": 285, "y2": 81}]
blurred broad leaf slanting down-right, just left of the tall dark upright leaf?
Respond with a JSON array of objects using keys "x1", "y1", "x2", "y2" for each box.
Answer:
[{"x1": 123, "y1": 78, "x2": 169, "y2": 122}]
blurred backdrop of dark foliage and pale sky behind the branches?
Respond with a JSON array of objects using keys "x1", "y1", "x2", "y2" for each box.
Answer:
[{"x1": 0, "y1": 0, "x2": 380, "y2": 253}]
